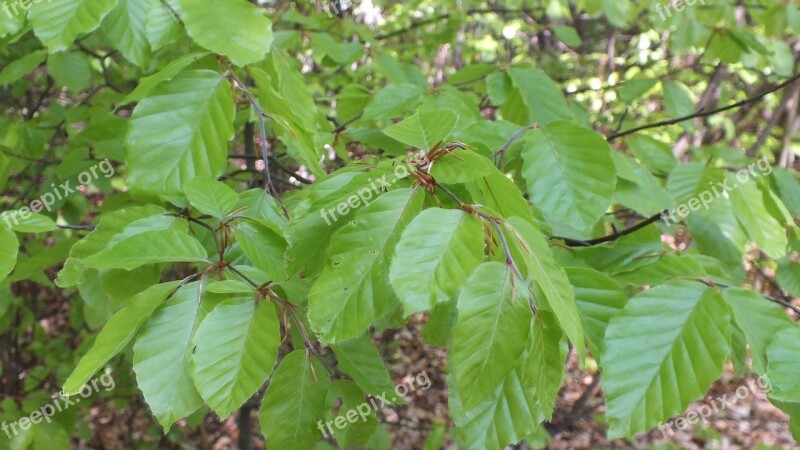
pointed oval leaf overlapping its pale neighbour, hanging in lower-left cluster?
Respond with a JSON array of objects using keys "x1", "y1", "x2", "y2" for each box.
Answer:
[{"x1": 192, "y1": 296, "x2": 281, "y2": 419}]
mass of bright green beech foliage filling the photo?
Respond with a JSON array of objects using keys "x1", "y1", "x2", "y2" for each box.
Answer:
[{"x1": 0, "y1": 0, "x2": 800, "y2": 449}]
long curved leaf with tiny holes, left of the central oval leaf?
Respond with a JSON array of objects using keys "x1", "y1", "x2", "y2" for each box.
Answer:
[{"x1": 308, "y1": 189, "x2": 424, "y2": 343}]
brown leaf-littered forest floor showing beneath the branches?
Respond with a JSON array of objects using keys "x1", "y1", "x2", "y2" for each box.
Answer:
[{"x1": 75, "y1": 317, "x2": 800, "y2": 450}]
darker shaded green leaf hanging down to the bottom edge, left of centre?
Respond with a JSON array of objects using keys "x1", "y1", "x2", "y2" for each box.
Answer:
[{"x1": 259, "y1": 350, "x2": 331, "y2": 450}]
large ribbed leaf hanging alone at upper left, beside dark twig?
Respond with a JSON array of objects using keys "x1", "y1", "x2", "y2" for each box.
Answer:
[{"x1": 128, "y1": 70, "x2": 234, "y2": 196}]
